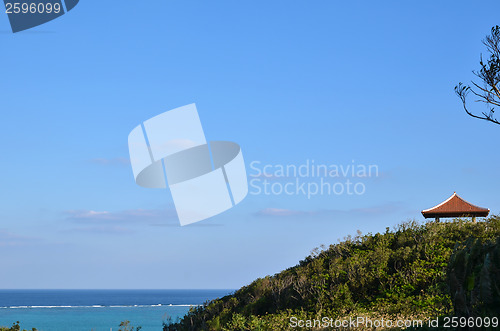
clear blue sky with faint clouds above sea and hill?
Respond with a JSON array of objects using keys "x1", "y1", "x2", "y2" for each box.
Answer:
[{"x1": 0, "y1": 0, "x2": 500, "y2": 288}]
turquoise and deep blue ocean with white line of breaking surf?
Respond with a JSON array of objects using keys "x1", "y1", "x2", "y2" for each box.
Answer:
[{"x1": 0, "y1": 290, "x2": 233, "y2": 331}]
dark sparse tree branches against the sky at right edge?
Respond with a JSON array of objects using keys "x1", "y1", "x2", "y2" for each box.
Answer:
[{"x1": 455, "y1": 25, "x2": 500, "y2": 125}]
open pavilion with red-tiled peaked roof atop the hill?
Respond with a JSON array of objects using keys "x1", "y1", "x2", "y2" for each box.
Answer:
[{"x1": 422, "y1": 192, "x2": 490, "y2": 222}]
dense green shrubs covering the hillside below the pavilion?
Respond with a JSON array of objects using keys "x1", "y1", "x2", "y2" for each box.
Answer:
[{"x1": 164, "y1": 216, "x2": 500, "y2": 331}]
